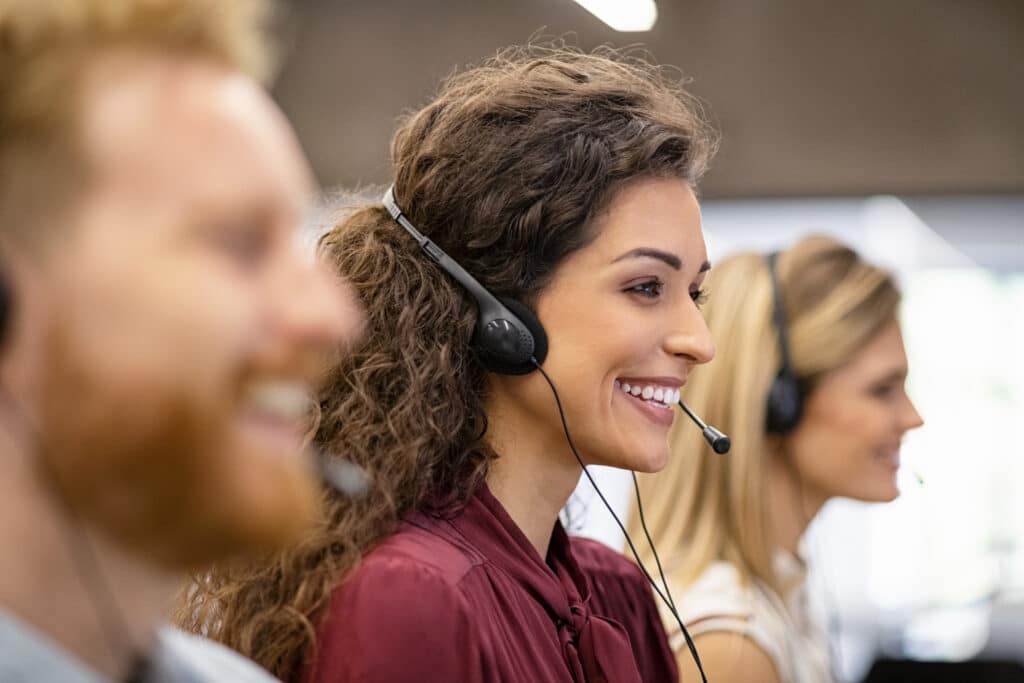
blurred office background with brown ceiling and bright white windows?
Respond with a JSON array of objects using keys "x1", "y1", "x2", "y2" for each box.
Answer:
[{"x1": 275, "y1": 0, "x2": 1024, "y2": 681}]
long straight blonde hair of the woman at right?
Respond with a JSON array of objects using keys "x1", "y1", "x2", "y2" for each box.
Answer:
[{"x1": 630, "y1": 237, "x2": 899, "y2": 594}]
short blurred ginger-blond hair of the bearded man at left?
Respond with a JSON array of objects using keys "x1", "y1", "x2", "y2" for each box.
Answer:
[{"x1": 0, "y1": 0, "x2": 271, "y2": 242}]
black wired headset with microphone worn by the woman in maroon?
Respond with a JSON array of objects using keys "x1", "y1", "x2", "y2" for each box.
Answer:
[{"x1": 381, "y1": 185, "x2": 730, "y2": 683}]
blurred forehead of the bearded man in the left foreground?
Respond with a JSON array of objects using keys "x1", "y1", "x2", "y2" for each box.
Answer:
[{"x1": 80, "y1": 53, "x2": 312, "y2": 218}]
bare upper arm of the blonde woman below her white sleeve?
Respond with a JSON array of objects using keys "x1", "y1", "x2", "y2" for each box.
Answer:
[{"x1": 677, "y1": 632, "x2": 781, "y2": 683}]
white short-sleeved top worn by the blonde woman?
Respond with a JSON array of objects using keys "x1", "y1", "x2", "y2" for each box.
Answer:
[{"x1": 658, "y1": 551, "x2": 834, "y2": 683}]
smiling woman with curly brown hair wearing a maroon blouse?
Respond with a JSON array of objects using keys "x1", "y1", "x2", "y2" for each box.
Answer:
[{"x1": 180, "y1": 48, "x2": 714, "y2": 683}]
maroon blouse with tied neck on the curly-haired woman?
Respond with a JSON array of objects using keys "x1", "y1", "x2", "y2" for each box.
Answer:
[{"x1": 299, "y1": 487, "x2": 678, "y2": 683}]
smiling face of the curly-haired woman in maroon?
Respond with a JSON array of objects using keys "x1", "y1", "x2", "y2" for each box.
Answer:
[{"x1": 493, "y1": 178, "x2": 715, "y2": 472}]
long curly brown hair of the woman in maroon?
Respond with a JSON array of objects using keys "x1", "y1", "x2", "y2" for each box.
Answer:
[{"x1": 179, "y1": 46, "x2": 715, "y2": 678}]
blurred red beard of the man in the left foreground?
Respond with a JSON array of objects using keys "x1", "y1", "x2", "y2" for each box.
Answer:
[{"x1": 38, "y1": 305, "x2": 318, "y2": 569}]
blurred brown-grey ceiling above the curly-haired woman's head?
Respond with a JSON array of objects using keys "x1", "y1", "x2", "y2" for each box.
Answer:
[{"x1": 274, "y1": 0, "x2": 1024, "y2": 198}]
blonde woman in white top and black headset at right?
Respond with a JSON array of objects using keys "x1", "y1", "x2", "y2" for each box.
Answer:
[{"x1": 630, "y1": 237, "x2": 922, "y2": 683}]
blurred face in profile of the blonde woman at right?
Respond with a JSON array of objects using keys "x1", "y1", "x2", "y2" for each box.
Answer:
[{"x1": 787, "y1": 321, "x2": 923, "y2": 502}]
